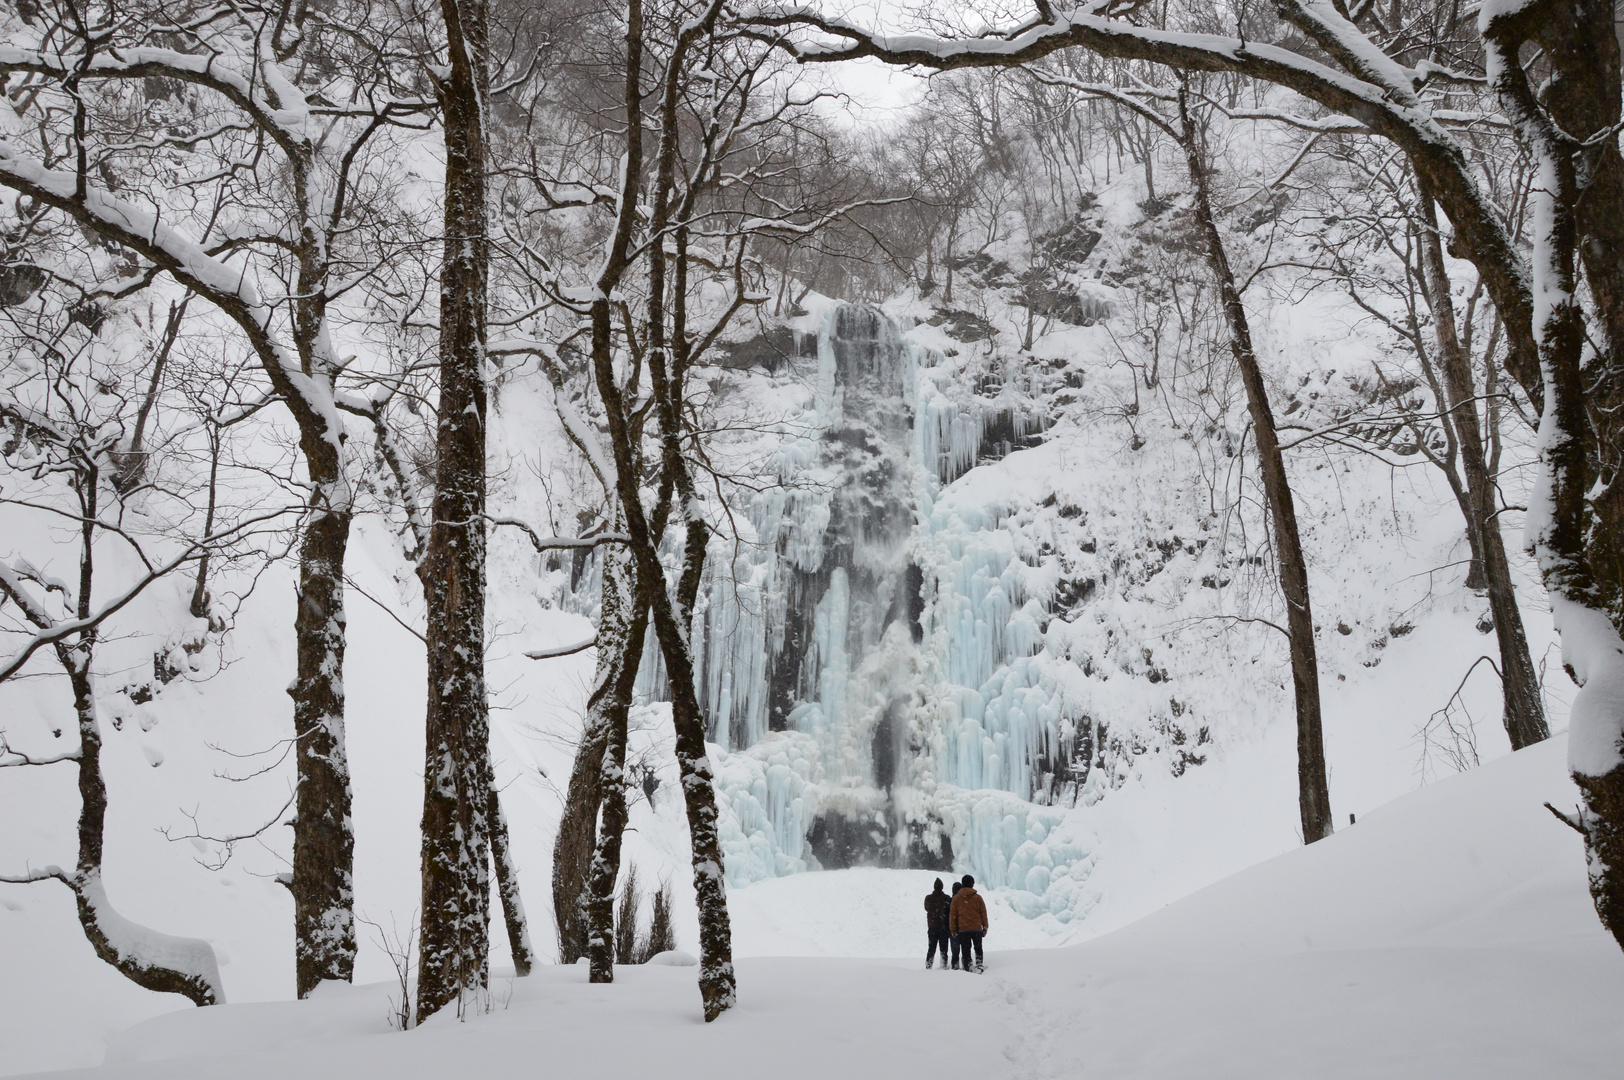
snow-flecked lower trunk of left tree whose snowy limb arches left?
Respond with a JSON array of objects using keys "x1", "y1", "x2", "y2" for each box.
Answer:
[{"x1": 289, "y1": 487, "x2": 356, "y2": 997}]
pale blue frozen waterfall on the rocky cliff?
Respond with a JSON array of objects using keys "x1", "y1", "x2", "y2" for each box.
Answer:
[{"x1": 672, "y1": 305, "x2": 1096, "y2": 922}]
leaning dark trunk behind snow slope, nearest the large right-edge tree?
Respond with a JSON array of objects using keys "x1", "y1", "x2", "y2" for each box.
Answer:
[{"x1": 1419, "y1": 197, "x2": 1551, "y2": 750}]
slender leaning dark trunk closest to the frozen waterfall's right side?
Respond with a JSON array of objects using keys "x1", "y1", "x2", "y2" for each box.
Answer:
[{"x1": 1179, "y1": 88, "x2": 1332, "y2": 845}]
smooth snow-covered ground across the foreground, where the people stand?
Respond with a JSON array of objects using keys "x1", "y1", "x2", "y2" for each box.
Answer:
[{"x1": 5, "y1": 736, "x2": 1624, "y2": 1080}]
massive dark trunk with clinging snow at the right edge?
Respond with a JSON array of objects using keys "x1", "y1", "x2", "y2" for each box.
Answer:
[{"x1": 1479, "y1": 0, "x2": 1624, "y2": 947}]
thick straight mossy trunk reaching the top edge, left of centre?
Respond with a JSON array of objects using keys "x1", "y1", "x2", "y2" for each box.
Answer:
[{"x1": 417, "y1": 0, "x2": 490, "y2": 1023}]
